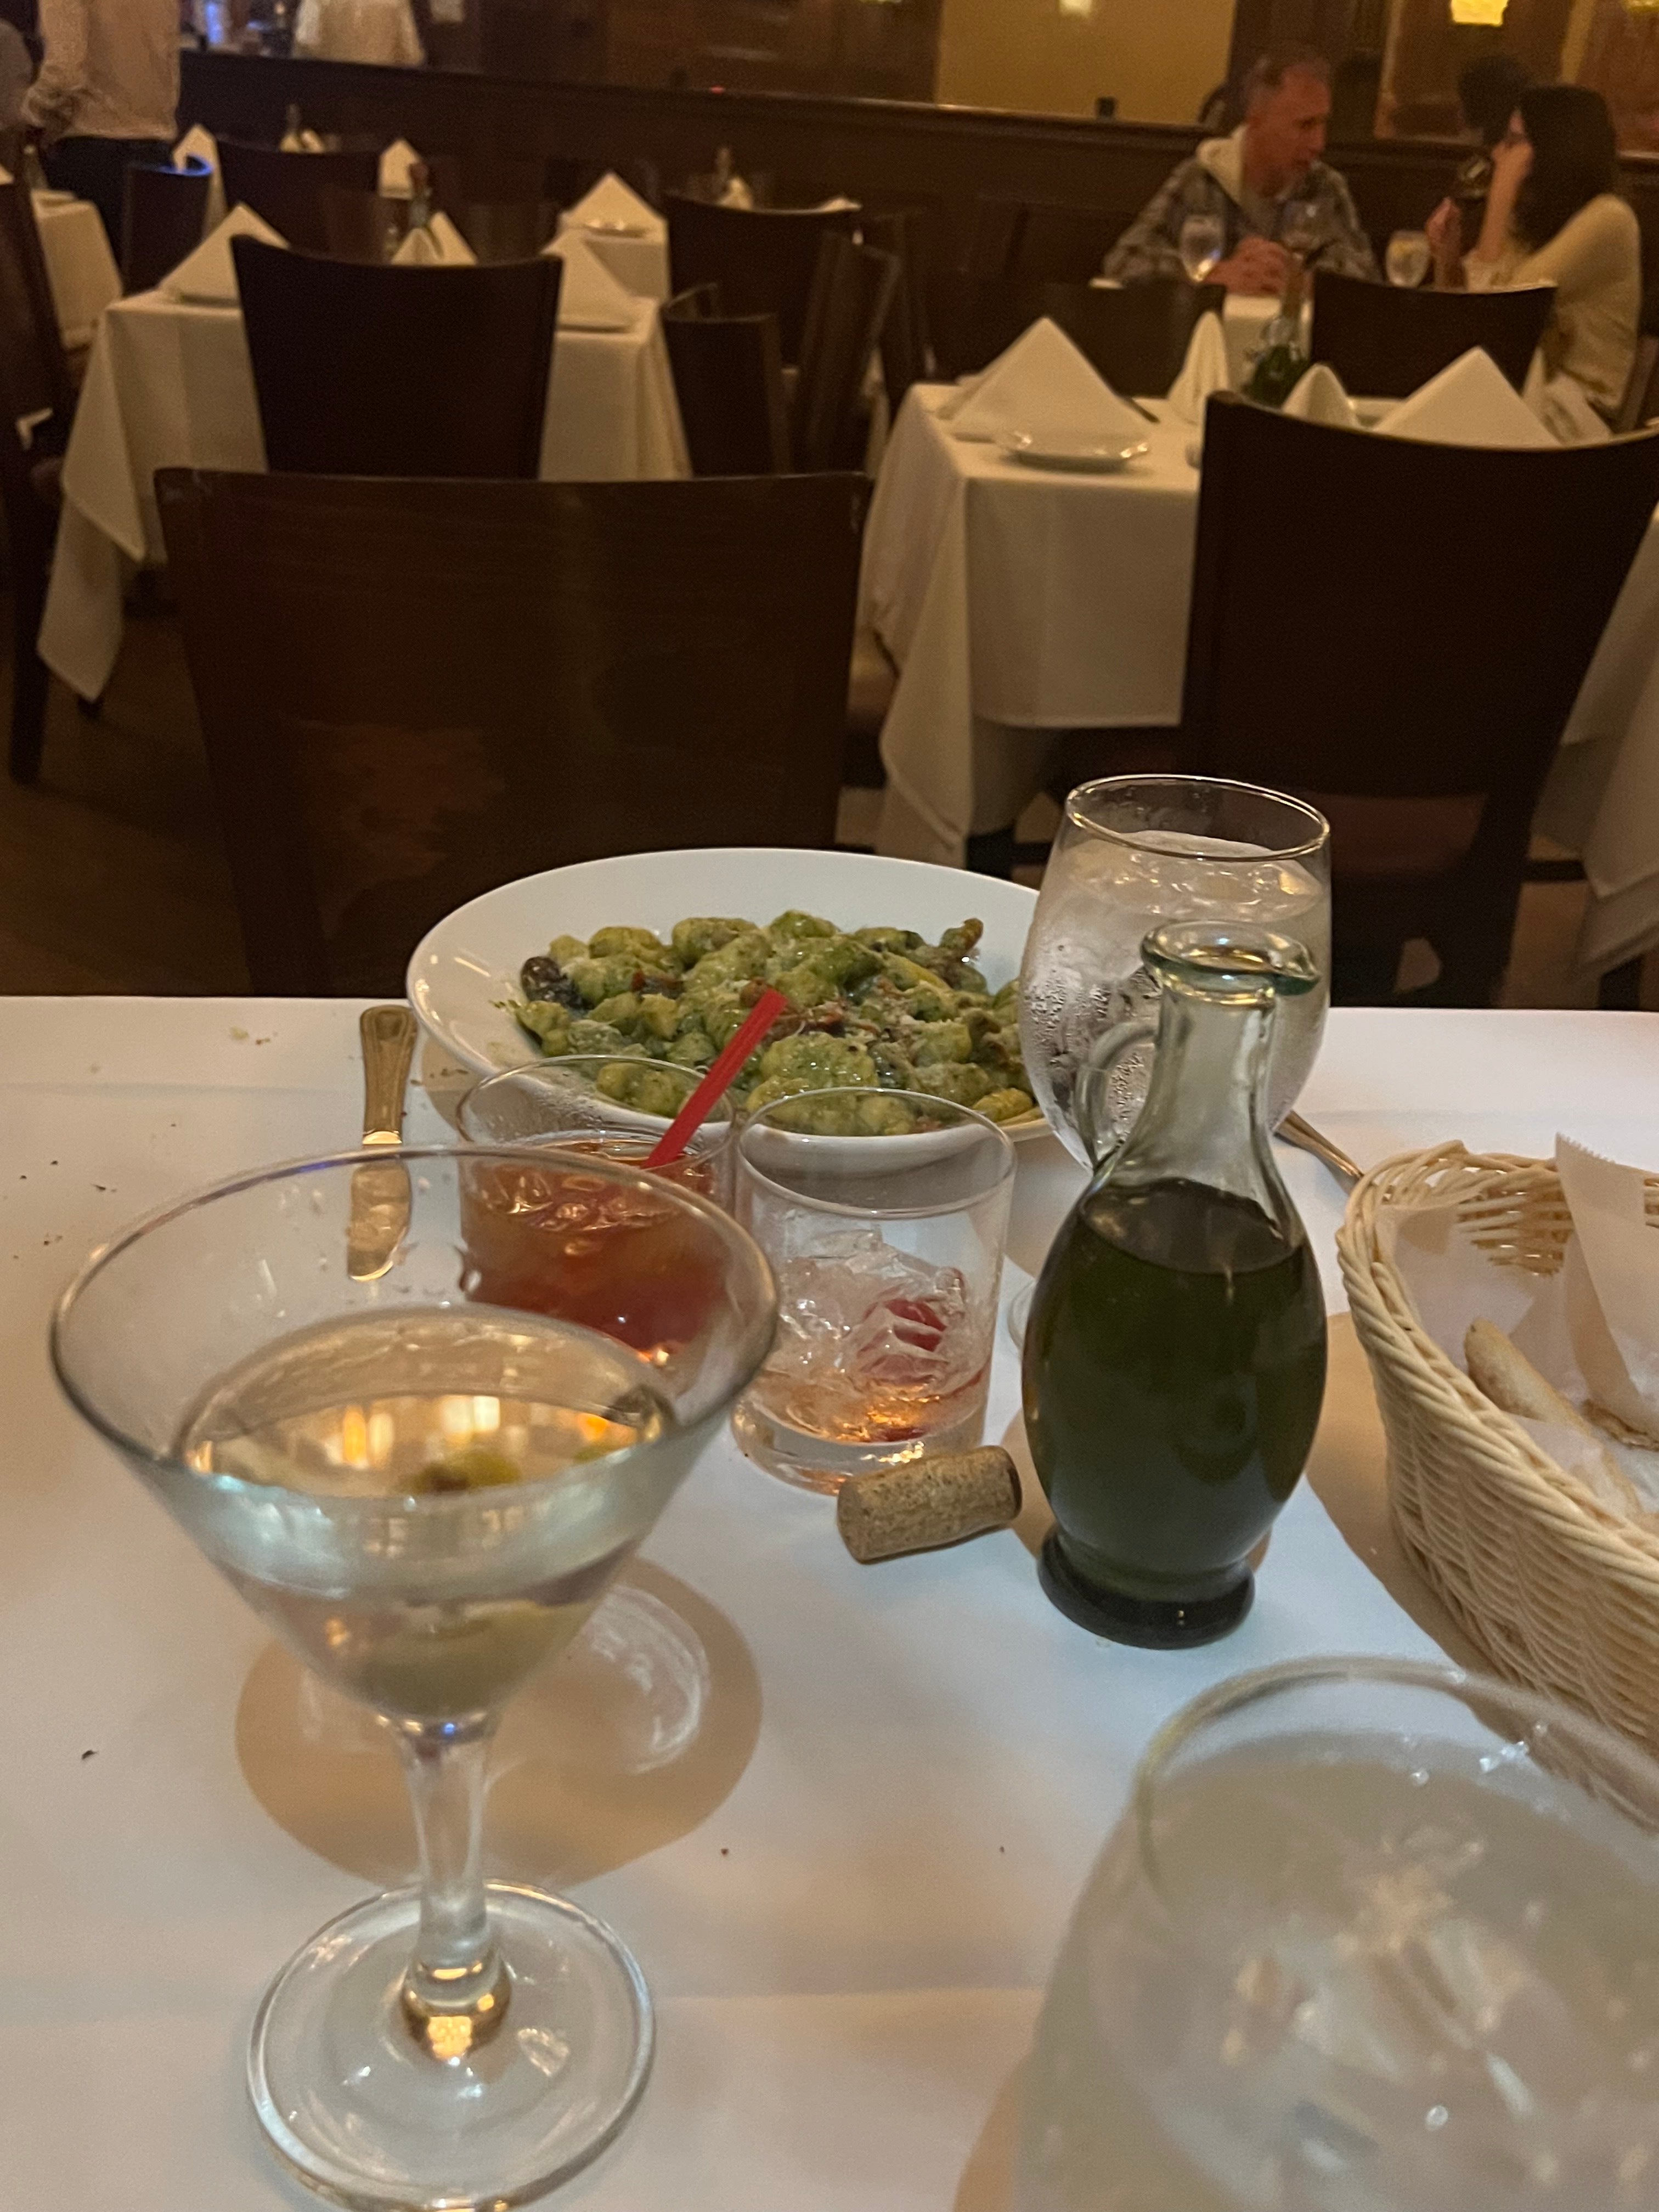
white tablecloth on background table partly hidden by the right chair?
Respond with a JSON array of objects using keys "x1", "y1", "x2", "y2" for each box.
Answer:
[{"x1": 860, "y1": 385, "x2": 1659, "y2": 975}]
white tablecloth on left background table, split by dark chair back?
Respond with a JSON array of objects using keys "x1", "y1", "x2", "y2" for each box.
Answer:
[{"x1": 40, "y1": 292, "x2": 690, "y2": 699}]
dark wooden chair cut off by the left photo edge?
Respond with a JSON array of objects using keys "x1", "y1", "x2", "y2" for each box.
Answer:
[{"x1": 0, "y1": 182, "x2": 75, "y2": 783}]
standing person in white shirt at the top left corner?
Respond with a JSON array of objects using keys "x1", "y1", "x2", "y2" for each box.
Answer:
[{"x1": 22, "y1": 0, "x2": 179, "y2": 252}]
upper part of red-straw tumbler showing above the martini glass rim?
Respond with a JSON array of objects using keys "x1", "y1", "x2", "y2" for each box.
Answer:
[{"x1": 458, "y1": 1053, "x2": 737, "y2": 1207}]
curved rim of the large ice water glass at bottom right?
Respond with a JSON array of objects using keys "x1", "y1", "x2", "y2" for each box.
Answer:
[{"x1": 1124, "y1": 1652, "x2": 1659, "y2": 1960}]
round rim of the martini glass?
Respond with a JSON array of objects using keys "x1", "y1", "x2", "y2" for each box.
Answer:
[{"x1": 49, "y1": 1144, "x2": 776, "y2": 1522}]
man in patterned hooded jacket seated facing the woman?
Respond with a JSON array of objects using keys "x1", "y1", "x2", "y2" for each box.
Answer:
[{"x1": 1104, "y1": 47, "x2": 1376, "y2": 294}]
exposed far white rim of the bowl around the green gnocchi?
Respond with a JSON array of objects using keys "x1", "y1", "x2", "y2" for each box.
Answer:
[{"x1": 409, "y1": 845, "x2": 1044, "y2": 1135}]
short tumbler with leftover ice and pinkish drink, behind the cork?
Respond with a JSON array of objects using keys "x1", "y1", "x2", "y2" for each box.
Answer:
[{"x1": 732, "y1": 1091, "x2": 1013, "y2": 1491}]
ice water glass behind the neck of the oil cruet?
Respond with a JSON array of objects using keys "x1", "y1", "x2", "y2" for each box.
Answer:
[{"x1": 1020, "y1": 776, "x2": 1331, "y2": 1166}]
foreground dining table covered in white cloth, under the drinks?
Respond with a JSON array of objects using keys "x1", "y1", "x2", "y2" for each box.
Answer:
[{"x1": 0, "y1": 997, "x2": 1659, "y2": 2212}]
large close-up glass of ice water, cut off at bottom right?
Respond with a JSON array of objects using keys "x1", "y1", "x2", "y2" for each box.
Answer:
[{"x1": 1013, "y1": 1659, "x2": 1659, "y2": 2212}]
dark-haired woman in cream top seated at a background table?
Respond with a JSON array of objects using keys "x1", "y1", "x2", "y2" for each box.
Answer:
[{"x1": 1429, "y1": 84, "x2": 1641, "y2": 420}]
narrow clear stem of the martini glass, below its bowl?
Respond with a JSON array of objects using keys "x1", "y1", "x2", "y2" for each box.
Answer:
[{"x1": 398, "y1": 1721, "x2": 513, "y2": 2062}]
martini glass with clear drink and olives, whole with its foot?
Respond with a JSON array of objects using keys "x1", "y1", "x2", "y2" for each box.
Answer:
[{"x1": 51, "y1": 1148, "x2": 774, "y2": 2212}]
